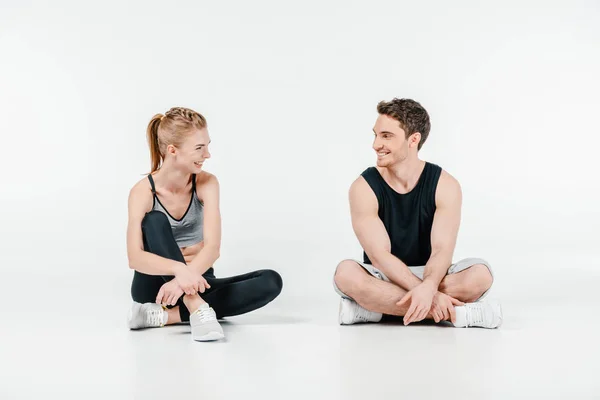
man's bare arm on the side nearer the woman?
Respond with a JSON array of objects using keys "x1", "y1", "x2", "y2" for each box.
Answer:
[{"x1": 349, "y1": 176, "x2": 421, "y2": 290}]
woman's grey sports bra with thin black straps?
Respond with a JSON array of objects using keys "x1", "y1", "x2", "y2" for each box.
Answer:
[{"x1": 148, "y1": 174, "x2": 204, "y2": 247}]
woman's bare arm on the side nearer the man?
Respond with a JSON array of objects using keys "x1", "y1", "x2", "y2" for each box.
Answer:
[{"x1": 188, "y1": 175, "x2": 221, "y2": 274}]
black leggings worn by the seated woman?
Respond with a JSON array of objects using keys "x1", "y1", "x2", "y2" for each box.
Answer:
[{"x1": 131, "y1": 211, "x2": 283, "y2": 321}]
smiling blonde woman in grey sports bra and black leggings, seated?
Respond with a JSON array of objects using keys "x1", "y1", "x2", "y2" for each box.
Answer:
[{"x1": 127, "y1": 107, "x2": 282, "y2": 341}]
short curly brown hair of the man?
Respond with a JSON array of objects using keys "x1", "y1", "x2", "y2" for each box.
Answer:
[{"x1": 377, "y1": 98, "x2": 431, "y2": 150}]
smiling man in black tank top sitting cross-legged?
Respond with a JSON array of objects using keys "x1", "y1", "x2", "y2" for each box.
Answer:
[{"x1": 334, "y1": 99, "x2": 502, "y2": 328}]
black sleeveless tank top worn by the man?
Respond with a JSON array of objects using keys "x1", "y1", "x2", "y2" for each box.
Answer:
[{"x1": 361, "y1": 162, "x2": 442, "y2": 267}]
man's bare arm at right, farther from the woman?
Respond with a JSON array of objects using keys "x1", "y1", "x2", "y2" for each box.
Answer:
[{"x1": 423, "y1": 171, "x2": 462, "y2": 289}]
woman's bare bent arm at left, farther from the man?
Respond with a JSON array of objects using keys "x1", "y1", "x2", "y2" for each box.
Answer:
[{"x1": 127, "y1": 181, "x2": 185, "y2": 275}]
